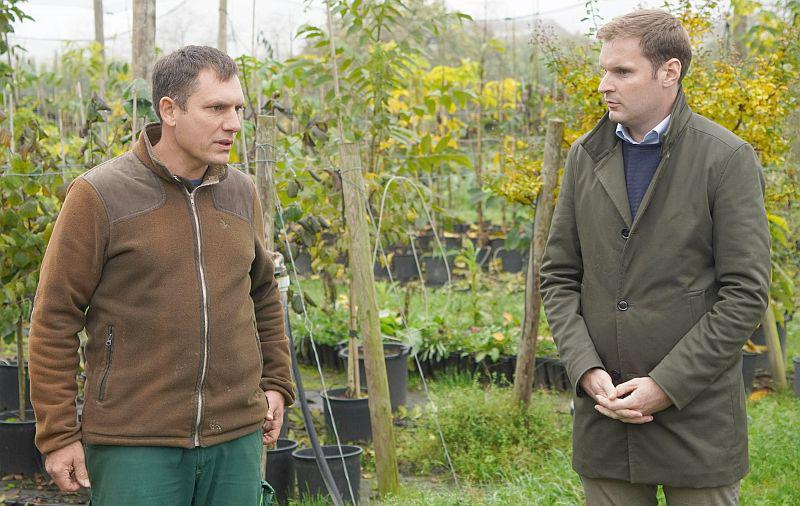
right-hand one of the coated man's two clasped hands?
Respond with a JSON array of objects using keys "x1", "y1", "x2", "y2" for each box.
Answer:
[{"x1": 595, "y1": 376, "x2": 672, "y2": 423}]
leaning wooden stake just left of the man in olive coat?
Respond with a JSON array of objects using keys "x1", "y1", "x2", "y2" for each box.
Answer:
[{"x1": 513, "y1": 119, "x2": 564, "y2": 407}]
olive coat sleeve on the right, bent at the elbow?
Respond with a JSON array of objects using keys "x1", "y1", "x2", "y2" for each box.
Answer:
[{"x1": 650, "y1": 140, "x2": 770, "y2": 409}]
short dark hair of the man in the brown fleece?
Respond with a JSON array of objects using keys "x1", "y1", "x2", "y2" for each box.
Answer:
[{"x1": 153, "y1": 46, "x2": 238, "y2": 120}]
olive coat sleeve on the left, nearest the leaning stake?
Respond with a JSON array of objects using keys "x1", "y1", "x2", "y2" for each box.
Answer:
[{"x1": 540, "y1": 144, "x2": 604, "y2": 395}]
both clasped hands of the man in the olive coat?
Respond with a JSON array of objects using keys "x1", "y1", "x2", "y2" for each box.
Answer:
[{"x1": 580, "y1": 369, "x2": 672, "y2": 424}]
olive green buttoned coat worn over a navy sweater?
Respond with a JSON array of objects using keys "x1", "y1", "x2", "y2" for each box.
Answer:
[{"x1": 541, "y1": 91, "x2": 770, "y2": 487}]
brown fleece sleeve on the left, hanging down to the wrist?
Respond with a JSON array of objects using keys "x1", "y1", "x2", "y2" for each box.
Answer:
[{"x1": 28, "y1": 178, "x2": 109, "y2": 453}]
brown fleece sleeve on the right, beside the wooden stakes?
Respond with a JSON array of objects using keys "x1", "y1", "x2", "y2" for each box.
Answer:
[{"x1": 250, "y1": 186, "x2": 294, "y2": 406}]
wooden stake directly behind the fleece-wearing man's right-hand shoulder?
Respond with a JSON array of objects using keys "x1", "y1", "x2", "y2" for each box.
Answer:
[{"x1": 260, "y1": 114, "x2": 278, "y2": 251}]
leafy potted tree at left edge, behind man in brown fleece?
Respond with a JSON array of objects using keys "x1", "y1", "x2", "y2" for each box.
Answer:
[{"x1": 0, "y1": 73, "x2": 64, "y2": 475}]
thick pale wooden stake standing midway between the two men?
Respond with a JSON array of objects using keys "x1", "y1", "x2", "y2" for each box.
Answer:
[{"x1": 339, "y1": 143, "x2": 399, "y2": 496}]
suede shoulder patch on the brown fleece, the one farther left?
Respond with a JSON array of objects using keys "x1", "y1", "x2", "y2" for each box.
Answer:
[{"x1": 81, "y1": 151, "x2": 167, "y2": 223}]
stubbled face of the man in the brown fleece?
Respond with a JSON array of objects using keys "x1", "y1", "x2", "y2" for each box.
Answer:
[{"x1": 175, "y1": 69, "x2": 244, "y2": 167}]
